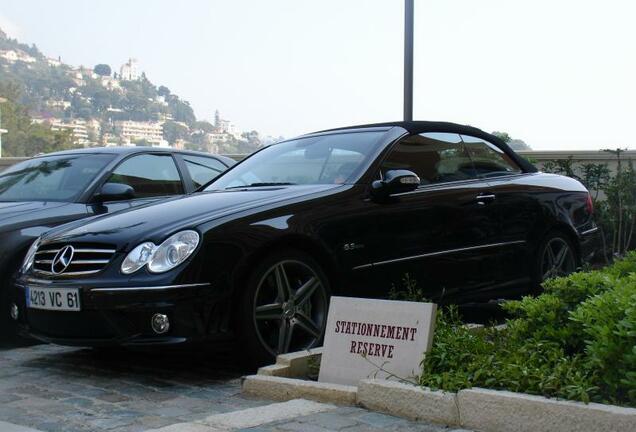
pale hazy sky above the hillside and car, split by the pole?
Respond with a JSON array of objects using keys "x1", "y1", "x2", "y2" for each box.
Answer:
[{"x1": 0, "y1": 0, "x2": 636, "y2": 150}]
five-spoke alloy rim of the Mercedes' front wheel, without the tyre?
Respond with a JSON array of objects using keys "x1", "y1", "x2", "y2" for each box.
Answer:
[{"x1": 253, "y1": 260, "x2": 328, "y2": 356}]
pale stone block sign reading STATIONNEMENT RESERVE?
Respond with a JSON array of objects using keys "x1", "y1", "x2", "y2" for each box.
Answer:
[{"x1": 318, "y1": 297, "x2": 436, "y2": 385}]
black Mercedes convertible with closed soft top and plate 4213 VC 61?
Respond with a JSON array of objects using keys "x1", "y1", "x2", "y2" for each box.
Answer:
[{"x1": 15, "y1": 122, "x2": 597, "y2": 364}]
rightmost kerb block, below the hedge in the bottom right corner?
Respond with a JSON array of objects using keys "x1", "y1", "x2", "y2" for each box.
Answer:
[{"x1": 457, "y1": 388, "x2": 636, "y2": 432}]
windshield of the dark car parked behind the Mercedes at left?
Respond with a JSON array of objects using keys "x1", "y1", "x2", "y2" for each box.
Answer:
[{"x1": 0, "y1": 154, "x2": 115, "y2": 202}]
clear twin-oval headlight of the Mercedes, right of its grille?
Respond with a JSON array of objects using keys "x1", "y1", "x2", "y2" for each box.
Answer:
[{"x1": 121, "y1": 231, "x2": 199, "y2": 274}]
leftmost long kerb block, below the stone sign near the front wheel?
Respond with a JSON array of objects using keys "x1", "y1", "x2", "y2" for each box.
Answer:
[{"x1": 243, "y1": 375, "x2": 358, "y2": 405}]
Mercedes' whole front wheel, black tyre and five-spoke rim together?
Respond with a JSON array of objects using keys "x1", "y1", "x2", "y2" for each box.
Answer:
[{"x1": 239, "y1": 249, "x2": 331, "y2": 367}]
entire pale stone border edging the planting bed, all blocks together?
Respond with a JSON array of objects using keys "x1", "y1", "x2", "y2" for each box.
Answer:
[{"x1": 243, "y1": 349, "x2": 636, "y2": 432}]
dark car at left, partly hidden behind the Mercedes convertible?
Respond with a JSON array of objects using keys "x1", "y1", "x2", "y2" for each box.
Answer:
[{"x1": 0, "y1": 147, "x2": 235, "y2": 335}]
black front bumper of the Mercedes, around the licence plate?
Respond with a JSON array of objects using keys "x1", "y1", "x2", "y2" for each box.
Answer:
[{"x1": 15, "y1": 279, "x2": 231, "y2": 346}]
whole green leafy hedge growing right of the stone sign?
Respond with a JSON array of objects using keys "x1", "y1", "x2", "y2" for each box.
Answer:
[{"x1": 420, "y1": 253, "x2": 636, "y2": 406}]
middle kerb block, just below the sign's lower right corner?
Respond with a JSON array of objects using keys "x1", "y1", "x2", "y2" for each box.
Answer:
[{"x1": 358, "y1": 379, "x2": 459, "y2": 426}]
